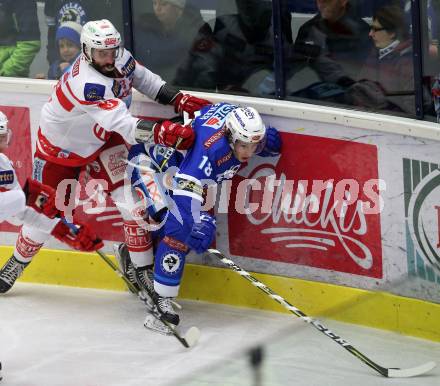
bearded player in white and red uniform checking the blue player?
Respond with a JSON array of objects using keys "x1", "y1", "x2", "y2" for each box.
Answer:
[{"x1": 0, "y1": 20, "x2": 209, "y2": 292}]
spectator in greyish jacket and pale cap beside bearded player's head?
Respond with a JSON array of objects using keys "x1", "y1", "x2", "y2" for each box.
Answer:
[{"x1": 134, "y1": 0, "x2": 212, "y2": 86}]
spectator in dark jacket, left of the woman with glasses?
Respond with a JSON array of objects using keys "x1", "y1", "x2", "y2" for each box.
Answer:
[{"x1": 293, "y1": 0, "x2": 371, "y2": 86}]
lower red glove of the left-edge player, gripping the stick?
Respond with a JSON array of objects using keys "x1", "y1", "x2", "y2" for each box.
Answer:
[{"x1": 51, "y1": 221, "x2": 104, "y2": 252}]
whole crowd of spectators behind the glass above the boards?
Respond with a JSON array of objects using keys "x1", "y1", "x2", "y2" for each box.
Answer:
[{"x1": 0, "y1": 0, "x2": 440, "y2": 121}]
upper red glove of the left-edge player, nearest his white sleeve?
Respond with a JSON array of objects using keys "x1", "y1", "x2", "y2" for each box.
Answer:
[{"x1": 23, "y1": 178, "x2": 59, "y2": 218}]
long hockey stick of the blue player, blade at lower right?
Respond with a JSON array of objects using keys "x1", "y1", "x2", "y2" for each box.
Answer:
[{"x1": 208, "y1": 249, "x2": 437, "y2": 378}]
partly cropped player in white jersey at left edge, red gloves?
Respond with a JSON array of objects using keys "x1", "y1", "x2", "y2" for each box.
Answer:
[{"x1": 0, "y1": 111, "x2": 103, "y2": 293}]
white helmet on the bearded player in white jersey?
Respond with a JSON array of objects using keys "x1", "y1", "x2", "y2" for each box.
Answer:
[{"x1": 81, "y1": 19, "x2": 121, "y2": 63}]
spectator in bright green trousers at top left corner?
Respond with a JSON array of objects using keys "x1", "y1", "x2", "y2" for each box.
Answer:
[{"x1": 0, "y1": 0, "x2": 40, "y2": 77}]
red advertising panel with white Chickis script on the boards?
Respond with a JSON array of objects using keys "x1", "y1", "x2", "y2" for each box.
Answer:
[{"x1": 228, "y1": 133, "x2": 383, "y2": 278}]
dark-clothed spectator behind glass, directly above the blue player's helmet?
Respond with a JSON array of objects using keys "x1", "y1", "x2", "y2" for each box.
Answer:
[{"x1": 186, "y1": 0, "x2": 292, "y2": 95}]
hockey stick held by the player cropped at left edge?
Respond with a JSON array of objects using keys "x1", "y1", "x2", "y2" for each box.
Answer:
[{"x1": 61, "y1": 217, "x2": 200, "y2": 348}]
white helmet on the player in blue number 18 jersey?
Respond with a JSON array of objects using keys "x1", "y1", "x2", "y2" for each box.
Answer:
[{"x1": 225, "y1": 107, "x2": 266, "y2": 145}]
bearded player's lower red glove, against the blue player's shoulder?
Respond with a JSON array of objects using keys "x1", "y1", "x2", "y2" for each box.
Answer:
[{"x1": 153, "y1": 121, "x2": 195, "y2": 150}]
